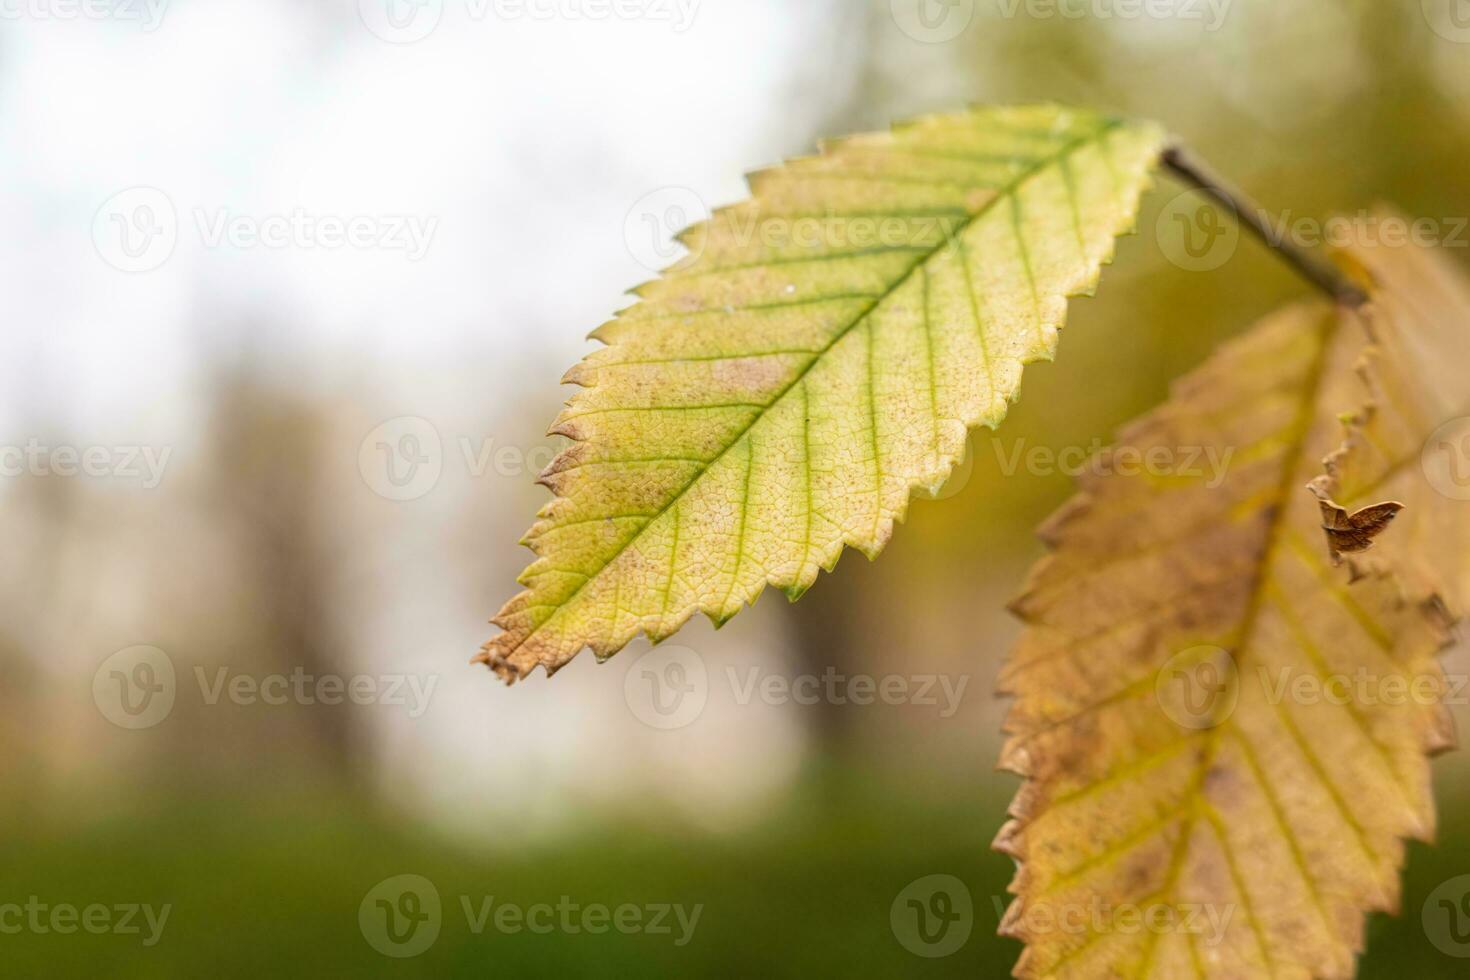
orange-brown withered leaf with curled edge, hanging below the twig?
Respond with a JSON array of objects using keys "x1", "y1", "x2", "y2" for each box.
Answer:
[{"x1": 997, "y1": 227, "x2": 1470, "y2": 980}]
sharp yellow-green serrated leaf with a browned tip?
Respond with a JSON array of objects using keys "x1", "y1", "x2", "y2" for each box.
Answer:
[{"x1": 481, "y1": 106, "x2": 1163, "y2": 680}]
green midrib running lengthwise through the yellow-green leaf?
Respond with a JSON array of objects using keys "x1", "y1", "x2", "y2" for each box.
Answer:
[{"x1": 511, "y1": 119, "x2": 1125, "y2": 658}]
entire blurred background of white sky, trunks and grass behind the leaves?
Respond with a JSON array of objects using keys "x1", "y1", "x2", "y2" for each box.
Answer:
[{"x1": 0, "y1": 0, "x2": 1470, "y2": 977}]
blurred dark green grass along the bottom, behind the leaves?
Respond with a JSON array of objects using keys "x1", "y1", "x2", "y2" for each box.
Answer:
[{"x1": 0, "y1": 767, "x2": 1470, "y2": 980}]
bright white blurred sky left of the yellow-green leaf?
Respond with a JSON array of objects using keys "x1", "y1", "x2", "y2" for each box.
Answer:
[{"x1": 0, "y1": 0, "x2": 848, "y2": 438}]
